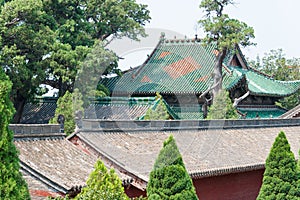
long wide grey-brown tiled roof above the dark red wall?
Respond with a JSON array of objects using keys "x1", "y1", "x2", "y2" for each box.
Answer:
[{"x1": 77, "y1": 126, "x2": 300, "y2": 182}]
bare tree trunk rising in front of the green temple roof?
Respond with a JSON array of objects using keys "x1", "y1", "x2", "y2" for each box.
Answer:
[{"x1": 212, "y1": 49, "x2": 227, "y2": 102}]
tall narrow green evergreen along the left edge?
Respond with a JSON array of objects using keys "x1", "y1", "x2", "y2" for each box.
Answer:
[{"x1": 0, "y1": 69, "x2": 30, "y2": 200}]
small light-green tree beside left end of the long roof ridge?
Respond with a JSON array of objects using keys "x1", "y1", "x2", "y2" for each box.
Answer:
[{"x1": 49, "y1": 91, "x2": 75, "y2": 135}]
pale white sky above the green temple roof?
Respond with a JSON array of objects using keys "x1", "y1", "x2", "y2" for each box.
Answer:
[{"x1": 131, "y1": 0, "x2": 300, "y2": 59}]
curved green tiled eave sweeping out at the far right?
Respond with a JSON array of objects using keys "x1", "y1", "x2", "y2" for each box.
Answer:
[{"x1": 231, "y1": 67, "x2": 300, "y2": 97}]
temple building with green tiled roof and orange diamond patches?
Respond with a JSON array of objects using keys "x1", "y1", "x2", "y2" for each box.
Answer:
[{"x1": 99, "y1": 36, "x2": 300, "y2": 119}]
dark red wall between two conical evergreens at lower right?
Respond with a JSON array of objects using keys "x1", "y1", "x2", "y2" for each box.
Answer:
[{"x1": 193, "y1": 169, "x2": 264, "y2": 200}]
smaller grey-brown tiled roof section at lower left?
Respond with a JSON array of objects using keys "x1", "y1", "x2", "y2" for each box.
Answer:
[{"x1": 15, "y1": 137, "x2": 96, "y2": 193}]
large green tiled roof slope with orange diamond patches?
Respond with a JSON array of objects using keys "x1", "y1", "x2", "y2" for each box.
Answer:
[{"x1": 113, "y1": 40, "x2": 242, "y2": 93}]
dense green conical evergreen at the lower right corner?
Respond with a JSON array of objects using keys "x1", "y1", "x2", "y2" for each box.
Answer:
[{"x1": 257, "y1": 132, "x2": 300, "y2": 200}]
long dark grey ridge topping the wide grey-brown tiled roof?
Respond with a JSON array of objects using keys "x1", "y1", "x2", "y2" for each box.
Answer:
[{"x1": 82, "y1": 119, "x2": 300, "y2": 131}]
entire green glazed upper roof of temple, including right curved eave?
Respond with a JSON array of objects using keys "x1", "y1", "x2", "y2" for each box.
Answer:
[{"x1": 104, "y1": 40, "x2": 300, "y2": 97}]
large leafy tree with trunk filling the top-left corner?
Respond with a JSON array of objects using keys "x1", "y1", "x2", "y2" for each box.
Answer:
[{"x1": 0, "y1": 0, "x2": 55, "y2": 123}]
